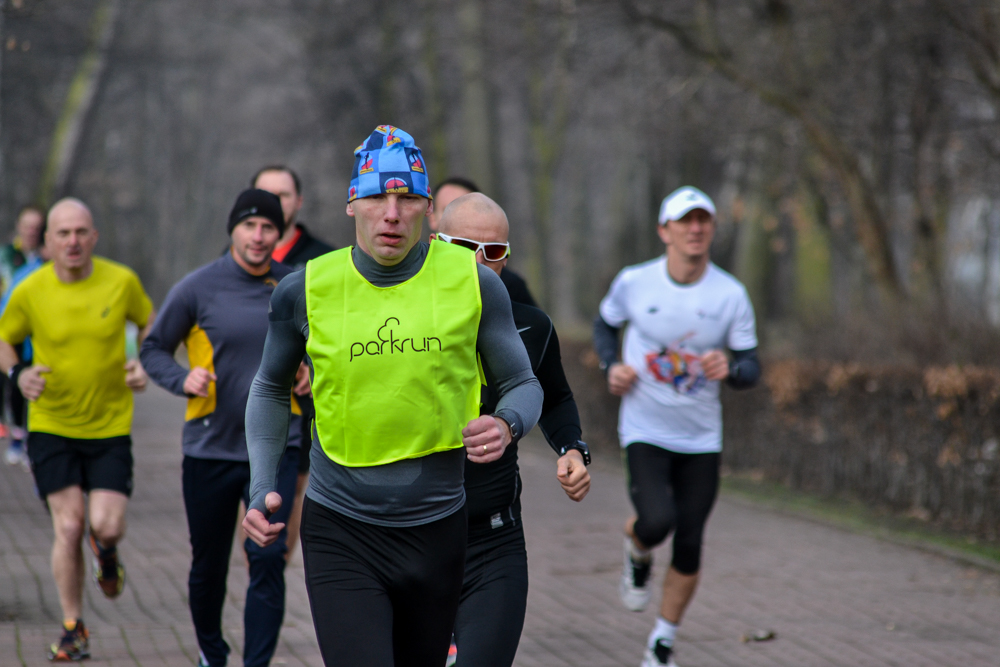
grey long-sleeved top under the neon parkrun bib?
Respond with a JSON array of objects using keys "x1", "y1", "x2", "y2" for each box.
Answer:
[{"x1": 246, "y1": 243, "x2": 543, "y2": 527}]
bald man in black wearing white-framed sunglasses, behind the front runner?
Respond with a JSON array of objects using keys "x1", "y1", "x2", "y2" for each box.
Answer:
[{"x1": 431, "y1": 193, "x2": 590, "y2": 667}]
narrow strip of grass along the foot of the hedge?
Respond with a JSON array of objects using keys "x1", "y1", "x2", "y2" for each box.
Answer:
[{"x1": 722, "y1": 473, "x2": 1000, "y2": 571}]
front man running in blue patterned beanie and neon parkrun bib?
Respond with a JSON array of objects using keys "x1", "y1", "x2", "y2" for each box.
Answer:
[{"x1": 243, "y1": 125, "x2": 543, "y2": 667}]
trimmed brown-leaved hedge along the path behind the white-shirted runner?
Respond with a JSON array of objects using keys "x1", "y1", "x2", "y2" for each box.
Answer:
[{"x1": 563, "y1": 342, "x2": 1000, "y2": 542}]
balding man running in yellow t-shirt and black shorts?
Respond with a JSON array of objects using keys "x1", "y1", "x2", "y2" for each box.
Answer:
[{"x1": 0, "y1": 199, "x2": 153, "y2": 661}]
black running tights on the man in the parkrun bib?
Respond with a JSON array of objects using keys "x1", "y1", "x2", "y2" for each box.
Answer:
[{"x1": 301, "y1": 496, "x2": 467, "y2": 667}]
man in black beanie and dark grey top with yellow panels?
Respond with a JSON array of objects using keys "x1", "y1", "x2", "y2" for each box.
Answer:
[{"x1": 141, "y1": 189, "x2": 301, "y2": 667}]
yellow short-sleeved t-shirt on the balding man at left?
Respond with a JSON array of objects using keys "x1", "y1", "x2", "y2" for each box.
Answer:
[{"x1": 0, "y1": 257, "x2": 153, "y2": 439}]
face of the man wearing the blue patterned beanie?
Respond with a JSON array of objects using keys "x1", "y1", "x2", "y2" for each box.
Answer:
[{"x1": 347, "y1": 194, "x2": 431, "y2": 266}]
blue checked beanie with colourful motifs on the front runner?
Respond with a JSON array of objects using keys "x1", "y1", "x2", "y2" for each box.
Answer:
[{"x1": 347, "y1": 125, "x2": 432, "y2": 203}]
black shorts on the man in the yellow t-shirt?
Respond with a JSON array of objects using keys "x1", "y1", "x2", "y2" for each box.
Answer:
[{"x1": 28, "y1": 431, "x2": 132, "y2": 498}]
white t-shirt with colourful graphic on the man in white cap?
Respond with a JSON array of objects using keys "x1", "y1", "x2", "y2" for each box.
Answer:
[{"x1": 601, "y1": 257, "x2": 757, "y2": 454}]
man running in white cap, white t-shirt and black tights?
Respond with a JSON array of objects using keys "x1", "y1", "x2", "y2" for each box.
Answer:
[{"x1": 594, "y1": 187, "x2": 760, "y2": 667}]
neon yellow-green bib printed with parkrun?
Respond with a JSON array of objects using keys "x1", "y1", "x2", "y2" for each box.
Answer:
[{"x1": 306, "y1": 241, "x2": 482, "y2": 466}]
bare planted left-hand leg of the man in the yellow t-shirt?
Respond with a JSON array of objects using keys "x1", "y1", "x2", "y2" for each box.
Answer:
[{"x1": 45, "y1": 486, "x2": 85, "y2": 619}]
